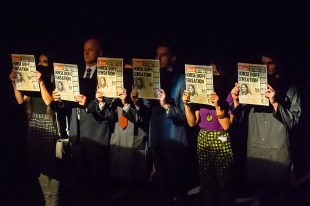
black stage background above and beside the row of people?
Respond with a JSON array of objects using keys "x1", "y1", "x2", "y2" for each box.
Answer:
[{"x1": 0, "y1": 0, "x2": 310, "y2": 203}]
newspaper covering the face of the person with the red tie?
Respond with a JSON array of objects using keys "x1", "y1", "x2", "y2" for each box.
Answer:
[{"x1": 97, "y1": 57, "x2": 123, "y2": 98}]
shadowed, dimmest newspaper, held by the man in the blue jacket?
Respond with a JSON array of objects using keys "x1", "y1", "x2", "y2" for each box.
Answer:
[{"x1": 132, "y1": 59, "x2": 160, "y2": 99}]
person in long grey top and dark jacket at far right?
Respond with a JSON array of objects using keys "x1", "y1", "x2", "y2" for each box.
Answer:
[{"x1": 231, "y1": 51, "x2": 301, "y2": 205}]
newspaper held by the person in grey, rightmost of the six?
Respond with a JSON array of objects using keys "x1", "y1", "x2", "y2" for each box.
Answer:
[{"x1": 238, "y1": 63, "x2": 269, "y2": 106}]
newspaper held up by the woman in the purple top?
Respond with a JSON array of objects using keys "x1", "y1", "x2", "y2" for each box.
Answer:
[{"x1": 185, "y1": 64, "x2": 214, "y2": 105}]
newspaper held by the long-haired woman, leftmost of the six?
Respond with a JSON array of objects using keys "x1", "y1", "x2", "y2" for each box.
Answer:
[{"x1": 11, "y1": 54, "x2": 40, "y2": 92}]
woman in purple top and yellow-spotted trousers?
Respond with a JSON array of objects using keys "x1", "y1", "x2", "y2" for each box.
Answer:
[{"x1": 182, "y1": 71, "x2": 234, "y2": 205}]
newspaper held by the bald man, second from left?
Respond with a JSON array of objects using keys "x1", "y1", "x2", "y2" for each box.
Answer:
[{"x1": 54, "y1": 63, "x2": 80, "y2": 102}]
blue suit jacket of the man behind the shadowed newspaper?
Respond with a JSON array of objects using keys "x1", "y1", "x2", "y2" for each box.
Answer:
[{"x1": 149, "y1": 71, "x2": 187, "y2": 150}]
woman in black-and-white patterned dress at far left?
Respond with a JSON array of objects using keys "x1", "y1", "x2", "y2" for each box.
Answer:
[{"x1": 10, "y1": 54, "x2": 59, "y2": 206}]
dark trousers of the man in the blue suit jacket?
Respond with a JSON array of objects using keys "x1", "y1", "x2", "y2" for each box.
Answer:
[{"x1": 153, "y1": 150, "x2": 188, "y2": 206}]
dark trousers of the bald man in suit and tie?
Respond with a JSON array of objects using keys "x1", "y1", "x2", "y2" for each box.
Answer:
[{"x1": 72, "y1": 138, "x2": 110, "y2": 205}]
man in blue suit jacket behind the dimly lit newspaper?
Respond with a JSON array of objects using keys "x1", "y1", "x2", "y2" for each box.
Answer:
[{"x1": 150, "y1": 44, "x2": 189, "y2": 206}]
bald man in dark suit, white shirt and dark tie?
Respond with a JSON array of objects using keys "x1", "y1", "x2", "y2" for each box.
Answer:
[{"x1": 53, "y1": 39, "x2": 114, "y2": 205}]
